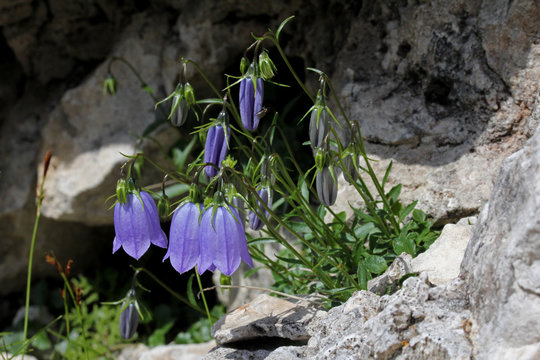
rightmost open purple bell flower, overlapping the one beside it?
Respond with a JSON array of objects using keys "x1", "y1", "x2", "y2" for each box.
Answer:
[{"x1": 198, "y1": 205, "x2": 253, "y2": 276}]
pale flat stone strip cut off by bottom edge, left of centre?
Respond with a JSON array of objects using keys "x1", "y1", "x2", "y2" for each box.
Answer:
[{"x1": 116, "y1": 340, "x2": 216, "y2": 360}]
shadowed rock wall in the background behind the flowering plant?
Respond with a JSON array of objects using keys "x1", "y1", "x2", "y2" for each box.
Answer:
[{"x1": 0, "y1": 0, "x2": 540, "y2": 338}]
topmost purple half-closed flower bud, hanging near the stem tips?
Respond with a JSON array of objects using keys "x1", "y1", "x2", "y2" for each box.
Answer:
[{"x1": 239, "y1": 77, "x2": 264, "y2": 131}]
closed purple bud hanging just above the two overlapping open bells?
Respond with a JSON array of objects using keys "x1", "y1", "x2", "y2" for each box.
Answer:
[{"x1": 204, "y1": 111, "x2": 230, "y2": 178}]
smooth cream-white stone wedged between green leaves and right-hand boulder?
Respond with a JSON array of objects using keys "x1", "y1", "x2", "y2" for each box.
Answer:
[{"x1": 411, "y1": 224, "x2": 473, "y2": 285}]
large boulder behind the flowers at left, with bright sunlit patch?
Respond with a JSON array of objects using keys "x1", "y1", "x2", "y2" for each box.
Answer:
[{"x1": 38, "y1": 17, "x2": 176, "y2": 225}]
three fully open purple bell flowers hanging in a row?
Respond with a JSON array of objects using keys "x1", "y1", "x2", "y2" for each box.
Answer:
[{"x1": 113, "y1": 181, "x2": 253, "y2": 278}]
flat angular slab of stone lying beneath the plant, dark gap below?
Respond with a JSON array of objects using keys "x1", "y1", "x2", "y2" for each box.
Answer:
[{"x1": 212, "y1": 294, "x2": 325, "y2": 344}]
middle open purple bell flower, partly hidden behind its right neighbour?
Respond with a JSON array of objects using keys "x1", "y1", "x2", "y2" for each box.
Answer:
[{"x1": 163, "y1": 202, "x2": 201, "y2": 274}]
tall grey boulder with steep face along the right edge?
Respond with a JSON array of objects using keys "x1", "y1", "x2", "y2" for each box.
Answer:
[{"x1": 462, "y1": 125, "x2": 540, "y2": 359}]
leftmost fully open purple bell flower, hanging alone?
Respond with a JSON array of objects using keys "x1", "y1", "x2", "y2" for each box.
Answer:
[{"x1": 113, "y1": 191, "x2": 167, "y2": 259}]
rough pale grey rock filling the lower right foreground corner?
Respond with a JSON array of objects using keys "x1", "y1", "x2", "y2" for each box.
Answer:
[{"x1": 204, "y1": 124, "x2": 540, "y2": 360}]
